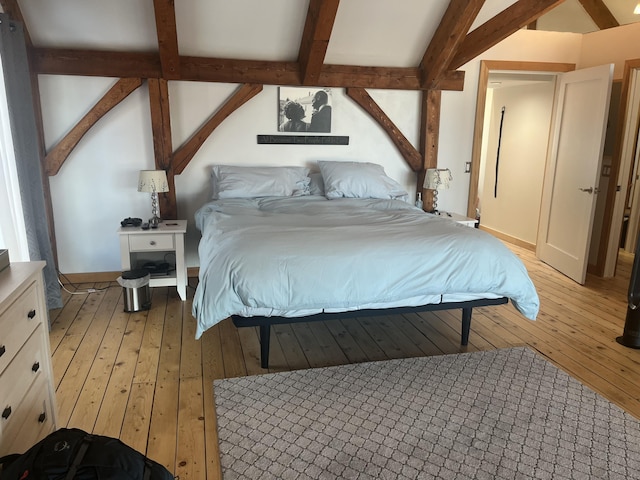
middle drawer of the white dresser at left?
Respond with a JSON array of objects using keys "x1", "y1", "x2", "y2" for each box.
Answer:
[{"x1": 0, "y1": 325, "x2": 47, "y2": 420}]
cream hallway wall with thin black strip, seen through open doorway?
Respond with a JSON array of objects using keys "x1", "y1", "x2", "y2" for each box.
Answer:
[{"x1": 480, "y1": 81, "x2": 555, "y2": 244}]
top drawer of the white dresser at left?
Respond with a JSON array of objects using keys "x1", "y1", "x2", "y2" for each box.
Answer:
[{"x1": 0, "y1": 284, "x2": 39, "y2": 374}]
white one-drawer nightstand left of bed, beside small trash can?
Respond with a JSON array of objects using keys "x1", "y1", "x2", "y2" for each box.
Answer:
[{"x1": 118, "y1": 220, "x2": 187, "y2": 301}]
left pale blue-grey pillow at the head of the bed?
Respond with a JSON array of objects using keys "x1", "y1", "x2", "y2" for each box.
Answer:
[{"x1": 211, "y1": 165, "x2": 310, "y2": 200}]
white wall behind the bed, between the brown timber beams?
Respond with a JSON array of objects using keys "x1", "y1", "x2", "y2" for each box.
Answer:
[{"x1": 40, "y1": 80, "x2": 420, "y2": 273}]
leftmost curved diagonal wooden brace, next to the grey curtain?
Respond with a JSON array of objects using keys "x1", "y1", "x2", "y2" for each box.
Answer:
[{"x1": 44, "y1": 78, "x2": 142, "y2": 176}]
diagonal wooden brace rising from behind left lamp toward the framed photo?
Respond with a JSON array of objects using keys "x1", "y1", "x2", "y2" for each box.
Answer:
[{"x1": 172, "y1": 84, "x2": 262, "y2": 175}]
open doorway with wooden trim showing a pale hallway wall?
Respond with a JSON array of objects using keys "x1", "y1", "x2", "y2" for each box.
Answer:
[{"x1": 467, "y1": 60, "x2": 575, "y2": 250}]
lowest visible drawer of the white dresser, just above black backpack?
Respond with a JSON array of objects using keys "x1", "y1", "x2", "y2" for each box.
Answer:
[{"x1": 0, "y1": 376, "x2": 54, "y2": 456}]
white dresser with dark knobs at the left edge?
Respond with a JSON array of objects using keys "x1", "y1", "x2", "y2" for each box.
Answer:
[{"x1": 0, "y1": 262, "x2": 57, "y2": 456}]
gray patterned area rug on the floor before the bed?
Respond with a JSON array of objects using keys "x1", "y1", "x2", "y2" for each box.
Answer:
[{"x1": 214, "y1": 347, "x2": 640, "y2": 480}]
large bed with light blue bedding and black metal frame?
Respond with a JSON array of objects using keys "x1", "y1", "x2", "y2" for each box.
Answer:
[{"x1": 193, "y1": 162, "x2": 539, "y2": 368}]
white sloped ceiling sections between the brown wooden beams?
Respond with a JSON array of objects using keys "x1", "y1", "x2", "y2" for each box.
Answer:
[{"x1": 10, "y1": 0, "x2": 640, "y2": 63}]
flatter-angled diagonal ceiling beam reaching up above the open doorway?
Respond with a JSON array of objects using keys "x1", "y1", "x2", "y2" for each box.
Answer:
[{"x1": 449, "y1": 0, "x2": 564, "y2": 70}]
